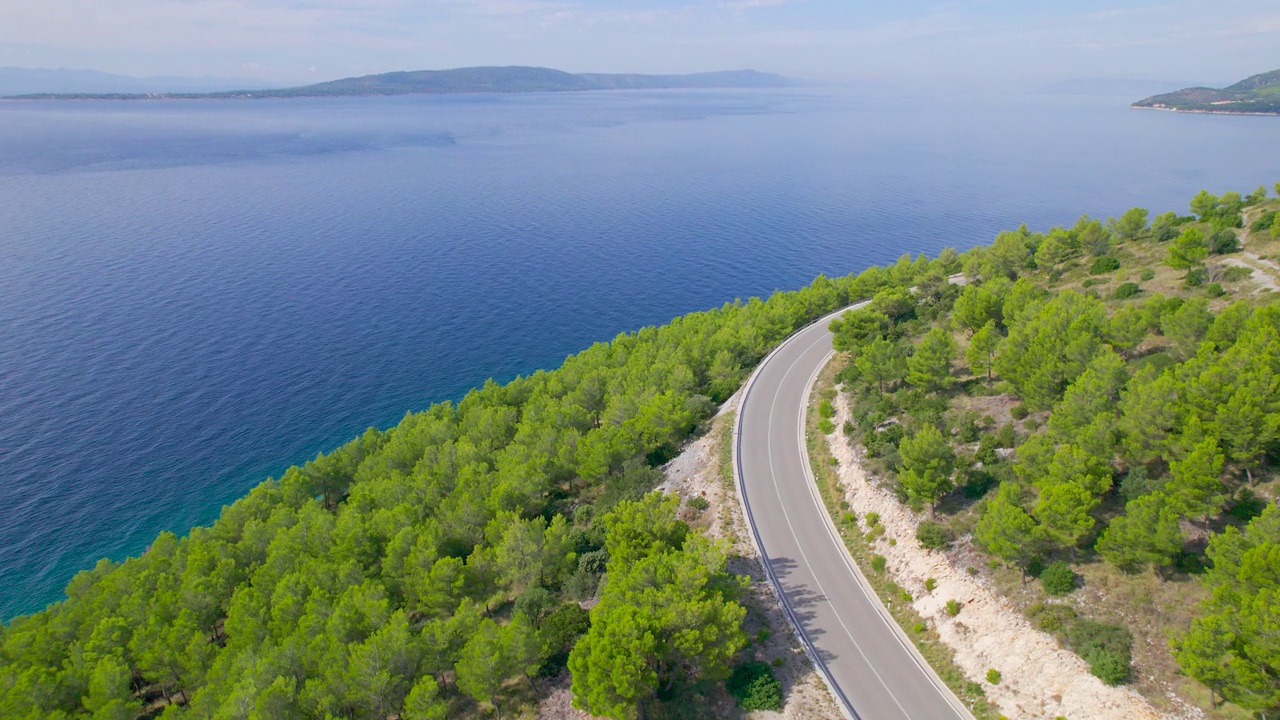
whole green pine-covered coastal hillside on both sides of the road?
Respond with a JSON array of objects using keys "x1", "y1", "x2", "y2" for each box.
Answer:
[{"x1": 0, "y1": 181, "x2": 1280, "y2": 720}]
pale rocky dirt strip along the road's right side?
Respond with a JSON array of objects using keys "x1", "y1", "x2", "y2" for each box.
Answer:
[{"x1": 827, "y1": 395, "x2": 1182, "y2": 720}]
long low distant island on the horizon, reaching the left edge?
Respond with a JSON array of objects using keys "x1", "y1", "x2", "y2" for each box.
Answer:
[{"x1": 9, "y1": 67, "x2": 796, "y2": 100}]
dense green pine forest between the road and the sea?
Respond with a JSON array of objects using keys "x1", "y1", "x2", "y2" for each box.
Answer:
[{"x1": 0, "y1": 252, "x2": 956, "y2": 720}]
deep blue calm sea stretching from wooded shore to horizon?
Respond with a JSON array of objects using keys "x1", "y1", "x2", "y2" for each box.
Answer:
[{"x1": 0, "y1": 91, "x2": 1280, "y2": 618}]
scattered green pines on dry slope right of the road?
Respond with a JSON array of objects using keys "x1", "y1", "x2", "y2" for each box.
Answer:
[{"x1": 828, "y1": 183, "x2": 1280, "y2": 716}]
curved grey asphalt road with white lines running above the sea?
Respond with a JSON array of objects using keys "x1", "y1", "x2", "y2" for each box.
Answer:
[{"x1": 733, "y1": 305, "x2": 973, "y2": 720}]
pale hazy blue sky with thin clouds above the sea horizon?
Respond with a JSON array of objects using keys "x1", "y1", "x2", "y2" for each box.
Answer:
[{"x1": 0, "y1": 0, "x2": 1280, "y2": 83}]
